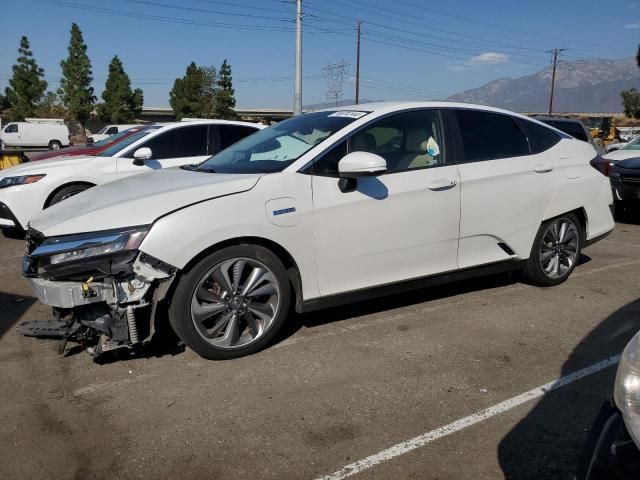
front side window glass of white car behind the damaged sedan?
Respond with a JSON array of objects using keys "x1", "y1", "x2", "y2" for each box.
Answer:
[{"x1": 134, "y1": 125, "x2": 207, "y2": 160}]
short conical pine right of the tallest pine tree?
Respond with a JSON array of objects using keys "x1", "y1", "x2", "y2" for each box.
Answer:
[{"x1": 98, "y1": 55, "x2": 143, "y2": 123}]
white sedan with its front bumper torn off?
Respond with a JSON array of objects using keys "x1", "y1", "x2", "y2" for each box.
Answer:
[{"x1": 23, "y1": 102, "x2": 614, "y2": 359}]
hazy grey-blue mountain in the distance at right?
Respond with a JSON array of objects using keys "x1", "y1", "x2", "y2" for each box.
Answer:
[{"x1": 447, "y1": 58, "x2": 640, "y2": 112}]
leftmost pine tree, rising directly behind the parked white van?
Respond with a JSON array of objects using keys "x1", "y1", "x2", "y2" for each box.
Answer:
[{"x1": 3, "y1": 37, "x2": 47, "y2": 120}]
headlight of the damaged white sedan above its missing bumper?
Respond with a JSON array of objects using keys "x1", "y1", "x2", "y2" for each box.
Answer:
[{"x1": 31, "y1": 225, "x2": 149, "y2": 265}]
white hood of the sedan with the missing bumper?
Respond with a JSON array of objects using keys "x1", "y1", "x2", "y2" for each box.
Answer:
[{"x1": 29, "y1": 168, "x2": 262, "y2": 237}]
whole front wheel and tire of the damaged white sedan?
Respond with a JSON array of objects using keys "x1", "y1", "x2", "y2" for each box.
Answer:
[{"x1": 169, "y1": 245, "x2": 291, "y2": 360}]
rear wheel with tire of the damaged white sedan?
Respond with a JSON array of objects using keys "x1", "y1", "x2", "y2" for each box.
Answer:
[{"x1": 523, "y1": 213, "x2": 584, "y2": 287}]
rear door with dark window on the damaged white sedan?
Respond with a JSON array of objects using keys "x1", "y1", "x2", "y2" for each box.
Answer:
[{"x1": 448, "y1": 109, "x2": 557, "y2": 268}]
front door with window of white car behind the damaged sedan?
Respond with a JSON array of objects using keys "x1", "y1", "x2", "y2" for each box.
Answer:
[{"x1": 112, "y1": 124, "x2": 210, "y2": 177}]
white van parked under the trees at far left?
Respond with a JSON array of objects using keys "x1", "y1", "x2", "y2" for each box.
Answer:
[{"x1": 0, "y1": 120, "x2": 69, "y2": 150}]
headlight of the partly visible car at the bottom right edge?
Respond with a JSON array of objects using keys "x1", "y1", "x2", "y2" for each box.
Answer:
[{"x1": 613, "y1": 332, "x2": 640, "y2": 448}]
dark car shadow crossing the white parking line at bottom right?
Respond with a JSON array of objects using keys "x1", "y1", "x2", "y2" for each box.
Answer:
[{"x1": 498, "y1": 299, "x2": 640, "y2": 480}]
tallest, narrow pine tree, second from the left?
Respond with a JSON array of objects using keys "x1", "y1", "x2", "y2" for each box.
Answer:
[{"x1": 58, "y1": 23, "x2": 96, "y2": 134}]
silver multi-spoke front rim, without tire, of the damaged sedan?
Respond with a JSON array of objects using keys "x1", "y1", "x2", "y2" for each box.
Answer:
[{"x1": 191, "y1": 258, "x2": 281, "y2": 349}]
